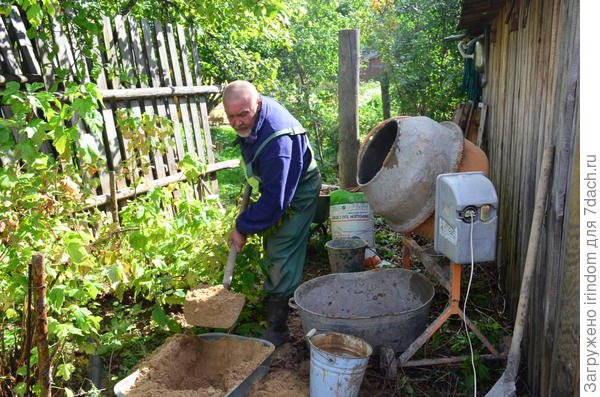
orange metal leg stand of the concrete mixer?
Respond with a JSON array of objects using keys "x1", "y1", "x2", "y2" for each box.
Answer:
[{"x1": 398, "y1": 235, "x2": 506, "y2": 367}]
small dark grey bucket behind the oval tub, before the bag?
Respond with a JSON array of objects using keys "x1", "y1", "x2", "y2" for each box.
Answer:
[{"x1": 325, "y1": 237, "x2": 367, "y2": 273}]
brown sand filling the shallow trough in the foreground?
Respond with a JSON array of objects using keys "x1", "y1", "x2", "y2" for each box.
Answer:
[{"x1": 127, "y1": 335, "x2": 273, "y2": 397}]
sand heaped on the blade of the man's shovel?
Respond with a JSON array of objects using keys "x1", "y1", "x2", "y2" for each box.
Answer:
[{"x1": 183, "y1": 284, "x2": 246, "y2": 328}]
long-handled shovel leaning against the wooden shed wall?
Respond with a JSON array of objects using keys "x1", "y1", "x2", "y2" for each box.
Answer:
[{"x1": 485, "y1": 146, "x2": 554, "y2": 397}]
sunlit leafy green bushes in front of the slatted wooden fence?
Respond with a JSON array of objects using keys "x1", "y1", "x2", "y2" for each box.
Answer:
[{"x1": 0, "y1": 76, "x2": 262, "y2": 395}]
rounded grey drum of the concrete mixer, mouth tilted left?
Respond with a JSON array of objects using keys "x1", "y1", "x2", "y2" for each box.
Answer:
[{"x1": 357, "y1": 116, "x2": 468, "y2": 238}]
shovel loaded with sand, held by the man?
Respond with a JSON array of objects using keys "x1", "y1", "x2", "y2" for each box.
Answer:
[{"x1": 183, "y1": 184, "x2": 252, "y2": 328}]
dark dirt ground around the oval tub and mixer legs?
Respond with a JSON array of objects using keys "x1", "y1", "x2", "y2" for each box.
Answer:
[{"x1": 246, "y1": 226, "x2": 516, "y2": 397}]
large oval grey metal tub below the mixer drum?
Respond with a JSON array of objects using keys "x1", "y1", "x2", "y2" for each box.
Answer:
[{"x1": 290, "y1": 269, "x2": 434, "y2": 352}]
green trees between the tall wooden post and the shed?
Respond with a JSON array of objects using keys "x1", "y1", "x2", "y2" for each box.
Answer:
[{"x1": 367, "y1": 0, "x2": 463, "y2": 120}]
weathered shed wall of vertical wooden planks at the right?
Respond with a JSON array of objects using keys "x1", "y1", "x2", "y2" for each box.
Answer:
[{"x1": 483, "y1": 0, "x2": 577, "y2": 395}]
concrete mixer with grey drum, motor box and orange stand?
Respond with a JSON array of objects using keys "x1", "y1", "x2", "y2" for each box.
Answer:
[{"x1": 357, "y1": 116, "x2": 503, "y2": 379}]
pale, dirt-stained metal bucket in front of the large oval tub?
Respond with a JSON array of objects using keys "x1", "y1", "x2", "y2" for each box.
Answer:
[{"x1": 308, "y1": 332, "x2": 373, "y2": 397}]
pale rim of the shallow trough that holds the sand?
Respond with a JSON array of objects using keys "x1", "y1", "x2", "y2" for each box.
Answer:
[{"x1": 113, "y1": 332, "x2": 275, "y2": 397}]
